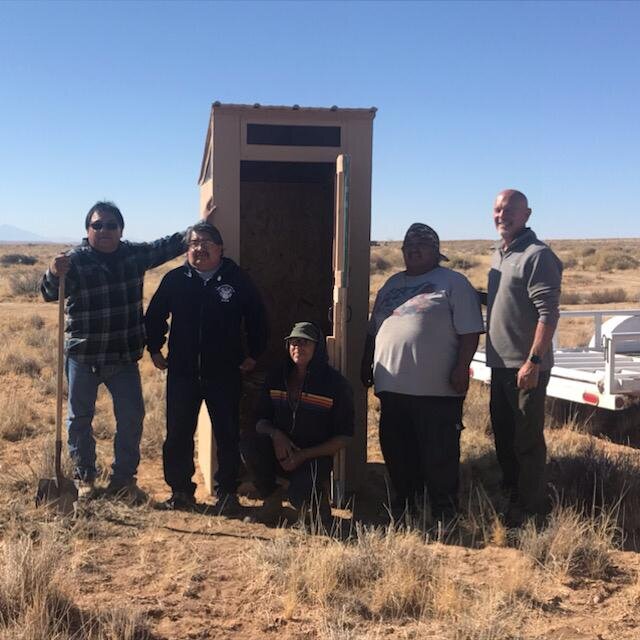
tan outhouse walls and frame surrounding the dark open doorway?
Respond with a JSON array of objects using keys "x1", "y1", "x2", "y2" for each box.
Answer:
[{"x1": 198, "y1": 103, "x2": 375, "y2": 491}]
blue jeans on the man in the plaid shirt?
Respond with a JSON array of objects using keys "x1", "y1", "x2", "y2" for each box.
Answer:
[{"x1": 66, "y1": 358, "x2": 144, "y2": 483}]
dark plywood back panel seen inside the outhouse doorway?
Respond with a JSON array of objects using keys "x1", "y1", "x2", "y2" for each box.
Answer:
[{"x1": 240, "y1": 172, "x2": 334, "y2": 367}]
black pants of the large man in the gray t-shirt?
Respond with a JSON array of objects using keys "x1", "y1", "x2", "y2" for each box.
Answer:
[{"x1": 379, "y1": 391, "x2": 464, "y2": 518}]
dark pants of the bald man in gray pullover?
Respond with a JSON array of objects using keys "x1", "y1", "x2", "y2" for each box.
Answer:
[{"x1": 489, "y1": 369, "x2": 550, "y2": 514}]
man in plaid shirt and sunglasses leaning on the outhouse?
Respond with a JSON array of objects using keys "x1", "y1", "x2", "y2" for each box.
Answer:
[{"x1": 41, "y1": 202, "x2": 213, "y2": 498}]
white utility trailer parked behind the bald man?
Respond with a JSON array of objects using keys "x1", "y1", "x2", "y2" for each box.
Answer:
[{"x1": 470, "y1": 309, "x2": 640, "y2": 411}]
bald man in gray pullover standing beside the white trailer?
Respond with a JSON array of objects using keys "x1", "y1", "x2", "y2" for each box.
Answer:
[{"x1": 487, "y1": 189, "x2": 562, "y2": 526}]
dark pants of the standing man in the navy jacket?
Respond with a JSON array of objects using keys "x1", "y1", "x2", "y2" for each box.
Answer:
[{"x1": 162, "y1": 371, "x2": 241, "y2": 495}]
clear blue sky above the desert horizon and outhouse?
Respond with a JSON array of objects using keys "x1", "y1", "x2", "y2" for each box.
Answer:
[{"x1": 0, "y1": 1, "x2": 640, "y2": 240}]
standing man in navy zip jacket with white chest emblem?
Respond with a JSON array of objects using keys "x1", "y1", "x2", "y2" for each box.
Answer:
[{"x1": 145, "y1": 223, "x2": 267, "y2": 509}]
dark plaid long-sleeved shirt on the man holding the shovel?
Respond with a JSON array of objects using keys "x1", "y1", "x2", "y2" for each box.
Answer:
[{"x1": 41, "y1": 233, "x2": 185, "y2": 365}]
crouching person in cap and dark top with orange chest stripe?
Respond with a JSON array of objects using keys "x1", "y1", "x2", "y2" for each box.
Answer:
[{"x1": 240, "y1": 322, "x2": 354, "y2": 522}]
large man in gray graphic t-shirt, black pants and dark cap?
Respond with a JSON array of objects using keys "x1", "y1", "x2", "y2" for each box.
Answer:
[{"x1": 362, "y1": 223, "x2": 484, "y2": 521}]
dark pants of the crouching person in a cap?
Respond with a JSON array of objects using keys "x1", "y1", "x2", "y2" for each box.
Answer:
[{"x1": 240, "y1": 431, "x2": 333, "y2": 513}]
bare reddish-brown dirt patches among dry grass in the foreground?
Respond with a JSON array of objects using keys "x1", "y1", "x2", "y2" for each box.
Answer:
[{"x1": 0, "y1": 428, "x2": 640, "y2": 640}]
